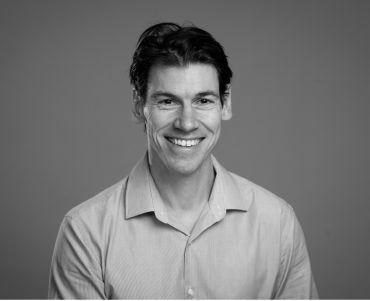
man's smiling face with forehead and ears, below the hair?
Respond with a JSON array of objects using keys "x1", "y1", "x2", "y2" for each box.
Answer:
[{"x1": 139, "y1": 64, "x2": 231, "y2": 175}]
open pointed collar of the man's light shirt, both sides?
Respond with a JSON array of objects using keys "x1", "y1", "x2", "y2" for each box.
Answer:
[{"x1": 125, "y1": 155, "x2": 253, "y2": 218}]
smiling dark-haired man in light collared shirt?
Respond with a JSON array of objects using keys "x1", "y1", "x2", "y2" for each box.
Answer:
[{"x1": 49, "y1": 23, "x2": 317, "y2": 299}]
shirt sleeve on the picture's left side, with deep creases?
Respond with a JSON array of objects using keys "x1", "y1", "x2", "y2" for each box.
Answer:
[{"x1": 48, "y1": 216, "x2": 106, "y2": 299}]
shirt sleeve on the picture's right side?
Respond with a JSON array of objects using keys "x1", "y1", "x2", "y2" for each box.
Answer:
[{"x1": 275, "y1": 207, "x2": 319, "y2": 299}]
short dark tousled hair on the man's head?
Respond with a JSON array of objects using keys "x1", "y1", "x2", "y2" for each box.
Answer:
[{"x1": 130, "y1": 23, "x2": 232, "y2": 101}]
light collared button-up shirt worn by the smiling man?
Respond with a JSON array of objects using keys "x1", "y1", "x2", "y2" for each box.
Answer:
[{"x1": 49, "y1": 156, "x2": 318, "y2": 299}]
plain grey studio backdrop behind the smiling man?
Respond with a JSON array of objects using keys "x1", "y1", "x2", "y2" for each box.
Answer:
[{"x1": 0, "y1": 0, "x2": 370, "y2": 298}]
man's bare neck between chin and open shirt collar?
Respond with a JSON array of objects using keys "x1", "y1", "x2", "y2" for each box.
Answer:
[{"x1": 150, "y1": 157, "x2": 215, "y2": 213}]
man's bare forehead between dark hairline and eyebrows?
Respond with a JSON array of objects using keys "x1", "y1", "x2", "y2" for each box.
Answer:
[{"x1": 148, "y1": 64, "x2": 219, "y2": 97}]
